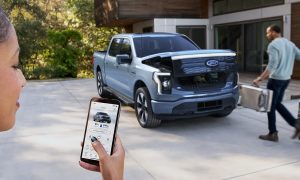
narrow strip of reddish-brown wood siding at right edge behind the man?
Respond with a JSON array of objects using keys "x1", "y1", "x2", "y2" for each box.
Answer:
[{"x1": 291, "y1": 3, "x2": 300, "y2": 79}]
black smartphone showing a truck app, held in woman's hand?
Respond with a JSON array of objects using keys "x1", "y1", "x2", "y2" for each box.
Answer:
[{"x1": 80, "y1": 97, "x2": 121, "y2": 165}]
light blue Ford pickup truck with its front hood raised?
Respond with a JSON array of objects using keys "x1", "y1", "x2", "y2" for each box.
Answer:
[{"x1": 93, "y1": 33, "x2": 239, "y2": 128}]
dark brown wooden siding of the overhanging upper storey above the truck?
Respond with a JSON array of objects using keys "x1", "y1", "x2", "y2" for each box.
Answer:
[{"x1": 94, "y1": 0, "x2": 208, "y2": 26}]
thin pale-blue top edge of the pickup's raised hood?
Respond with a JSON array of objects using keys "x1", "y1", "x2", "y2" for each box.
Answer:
[{"x1": 141, "y1": 49, "x2": 236, "y2": 62}]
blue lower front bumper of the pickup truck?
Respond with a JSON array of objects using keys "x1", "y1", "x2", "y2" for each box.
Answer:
[{"x1": 151, "y1": 90, "x2": 239, "y2": 119}]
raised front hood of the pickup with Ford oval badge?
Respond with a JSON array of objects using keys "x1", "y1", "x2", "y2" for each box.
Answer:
[{"x1": 141, "y1": 50, "x2": 236, "y2": 76}]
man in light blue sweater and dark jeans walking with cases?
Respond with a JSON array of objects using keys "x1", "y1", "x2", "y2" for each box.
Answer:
[{"x1": 253, "y1": 25, "x2": 300, "y2": 142}]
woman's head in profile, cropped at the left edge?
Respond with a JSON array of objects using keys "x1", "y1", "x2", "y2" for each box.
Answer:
[{"x1": 0, "y1": 7, "x2": 26, "y2": 131}]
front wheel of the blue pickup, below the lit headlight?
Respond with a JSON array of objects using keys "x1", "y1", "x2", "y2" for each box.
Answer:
[{"x1": 134, "y1": 87, "x2": 161, "y2": 128}]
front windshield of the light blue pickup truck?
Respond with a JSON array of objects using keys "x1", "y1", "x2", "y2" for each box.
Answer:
[{"x1": 133, "y1": 36, "x2": 200, "y2": 57}]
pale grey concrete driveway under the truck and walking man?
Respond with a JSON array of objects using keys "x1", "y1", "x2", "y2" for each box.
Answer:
[{"x1": 0, "y1": 79, "x2": 300, "y2": 180}]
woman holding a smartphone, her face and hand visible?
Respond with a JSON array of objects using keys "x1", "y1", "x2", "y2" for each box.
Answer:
[{"x1": 0, "y1": 7, "x2": 125, "y2": 179}]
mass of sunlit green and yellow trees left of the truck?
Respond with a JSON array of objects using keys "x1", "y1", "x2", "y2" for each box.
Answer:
[{"x1": 0, "y1": 0, "x2": 120, "y2": 79}]
